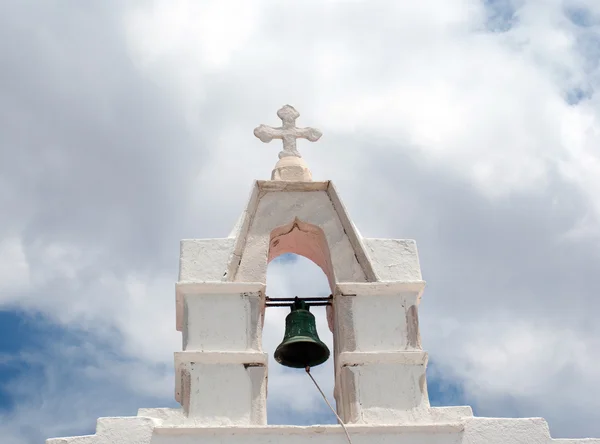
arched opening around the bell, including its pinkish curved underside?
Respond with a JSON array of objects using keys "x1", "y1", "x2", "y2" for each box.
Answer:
[{"x1": 262, "y1": 220, "x2": 337, "y2": 425}]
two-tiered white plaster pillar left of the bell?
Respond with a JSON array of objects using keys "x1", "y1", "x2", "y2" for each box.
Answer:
[{"x1": 171, "y1": 281, "x2": 267, "y2": 426}]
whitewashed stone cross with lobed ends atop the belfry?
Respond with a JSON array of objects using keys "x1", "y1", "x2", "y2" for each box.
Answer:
[{"x1": 254, "y1": 105, "x2": 322, "y2": 159}]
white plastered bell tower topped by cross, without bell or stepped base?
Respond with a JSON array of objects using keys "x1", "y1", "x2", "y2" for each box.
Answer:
[{"x1": 169, "y1": 106, "x2": 472, "y2": 425}]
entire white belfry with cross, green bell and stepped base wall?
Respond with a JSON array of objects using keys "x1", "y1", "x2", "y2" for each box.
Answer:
[{"x1": 47, "y1": 105, "x2": 600, "y2": 444}]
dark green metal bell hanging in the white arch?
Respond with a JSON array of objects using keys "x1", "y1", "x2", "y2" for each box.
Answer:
[{"x1": 275, "y1": 298, "x2": 329, "y2": 368}]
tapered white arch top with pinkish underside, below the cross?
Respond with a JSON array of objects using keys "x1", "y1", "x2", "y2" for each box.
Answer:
[{"x1": 230, "y1": 182, "x2": 370, "y2": 285}]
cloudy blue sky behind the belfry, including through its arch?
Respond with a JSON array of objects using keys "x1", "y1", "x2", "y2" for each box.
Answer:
[{"x1": 0, "y1": 0, "x2": 600, "y2": 444}]
